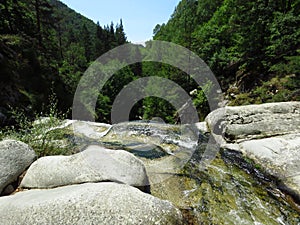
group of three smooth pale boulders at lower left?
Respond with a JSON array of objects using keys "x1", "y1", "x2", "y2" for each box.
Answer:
[{"x1": 0, "y1": 140, "x2": 183, "y2": 224}]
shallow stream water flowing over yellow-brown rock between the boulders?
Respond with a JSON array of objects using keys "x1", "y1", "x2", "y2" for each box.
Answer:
[{"x1": 101, "y1": 122, "x2": 300, "y2": 225}]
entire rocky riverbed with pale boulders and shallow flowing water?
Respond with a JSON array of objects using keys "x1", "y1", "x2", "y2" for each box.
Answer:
[{"x1": 0, "y1": 102, "x2": 300, "y2": 224}]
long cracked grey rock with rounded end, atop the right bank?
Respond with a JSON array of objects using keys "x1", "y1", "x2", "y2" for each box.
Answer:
[{"x1": 206, "y1": 102, "x2": 300, "y2": 144}]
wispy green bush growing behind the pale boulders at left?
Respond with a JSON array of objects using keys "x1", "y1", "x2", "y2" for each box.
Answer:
[{"x1": 0, "y1": 92, "x2": 69, "y2": 157}]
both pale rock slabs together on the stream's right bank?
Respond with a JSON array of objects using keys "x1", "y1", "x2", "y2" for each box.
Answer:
[{"x1": 206, "y1": 102, "x2": 300, "y2": 202}]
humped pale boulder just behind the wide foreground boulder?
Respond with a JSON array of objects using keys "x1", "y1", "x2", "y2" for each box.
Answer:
[{"x1": 21, "y1": 145, "x2": 149, "y2": 191}]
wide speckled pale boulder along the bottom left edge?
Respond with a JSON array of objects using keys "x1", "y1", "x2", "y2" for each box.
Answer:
[{"x1": 0, "y1": 182, "x2": 183, "y2": 225}]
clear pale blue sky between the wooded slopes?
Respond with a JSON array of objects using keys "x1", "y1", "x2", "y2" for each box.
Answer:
[{"x1": 61, "y1": 0, "x2": 180, "y2": 43}]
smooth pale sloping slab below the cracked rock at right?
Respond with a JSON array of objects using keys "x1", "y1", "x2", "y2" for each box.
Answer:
[{"x1": 239, "y1": 133, "x2": 300, "y2": 196}]
